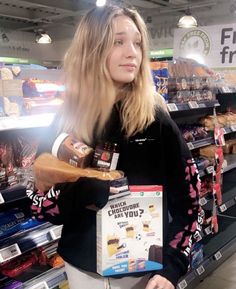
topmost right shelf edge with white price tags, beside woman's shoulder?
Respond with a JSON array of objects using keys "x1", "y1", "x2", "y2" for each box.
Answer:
[{"x1": 167, "y1": 100, "x2": 220, "y2": 112}]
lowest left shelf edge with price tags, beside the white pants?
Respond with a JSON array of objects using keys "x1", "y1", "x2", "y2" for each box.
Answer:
[{"x1": 22, "y1": 267, "x2": 67, "y2": 289}]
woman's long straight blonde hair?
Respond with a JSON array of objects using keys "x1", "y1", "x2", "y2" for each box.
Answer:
[{"x1": 61, "y1": 6, "x2": 166, "y2": 144}]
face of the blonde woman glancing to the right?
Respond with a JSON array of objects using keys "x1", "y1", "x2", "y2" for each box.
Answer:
[{"x1": 107, "y1": 15, "x2": 142, "y2": 86}]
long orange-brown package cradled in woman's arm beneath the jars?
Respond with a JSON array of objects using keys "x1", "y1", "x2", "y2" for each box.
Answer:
[{"x1": 33, "y1": 153, "x2": 123, "y2": 192}]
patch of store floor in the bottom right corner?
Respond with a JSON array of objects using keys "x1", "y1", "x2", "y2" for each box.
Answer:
[{"x1": 196, "y1": 253, "x2": 236, "y2": 289}]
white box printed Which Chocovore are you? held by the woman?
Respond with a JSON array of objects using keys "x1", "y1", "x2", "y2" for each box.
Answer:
[{"x1": 97, "y1": 185, "x2": 163, "y2": 276}]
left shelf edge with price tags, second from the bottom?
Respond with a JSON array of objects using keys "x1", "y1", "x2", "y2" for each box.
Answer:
[{"x1": 0, "y1": 223, "x2": 62, "y2": 264}]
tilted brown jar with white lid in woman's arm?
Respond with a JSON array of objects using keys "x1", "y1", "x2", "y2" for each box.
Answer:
[{"x1": 52, "y1": 133, "x2": 93, "y2": 168}]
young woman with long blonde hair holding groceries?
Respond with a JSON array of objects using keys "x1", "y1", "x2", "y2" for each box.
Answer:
[{"x1": 32, "y1": 6, "x2": 203, "y2": 289}]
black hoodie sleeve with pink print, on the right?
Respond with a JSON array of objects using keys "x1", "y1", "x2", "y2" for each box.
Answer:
[{"x1": 156, "y1": 111, "x2": 204, "y2": 286}]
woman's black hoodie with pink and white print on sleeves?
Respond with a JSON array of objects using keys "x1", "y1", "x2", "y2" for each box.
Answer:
[{"x1": 31, "y1": 107, "x2": 202, "y2": 286}]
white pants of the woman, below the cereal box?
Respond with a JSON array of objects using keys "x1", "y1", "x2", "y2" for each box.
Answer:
[{"x1": 65, "y1": 262, "x2": 150, "y2": 289}]
